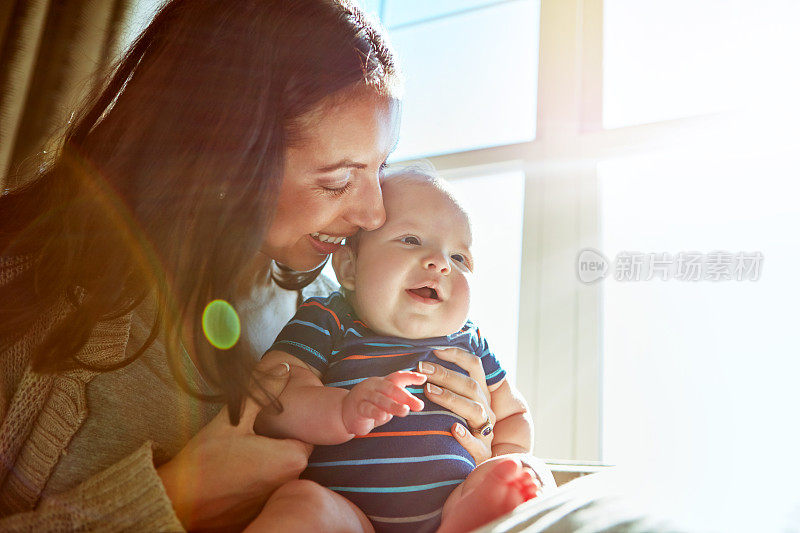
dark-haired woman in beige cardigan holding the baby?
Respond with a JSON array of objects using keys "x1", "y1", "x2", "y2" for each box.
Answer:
[{"x1": 0, "y1": 0, "x2": 512, "y2": 530}]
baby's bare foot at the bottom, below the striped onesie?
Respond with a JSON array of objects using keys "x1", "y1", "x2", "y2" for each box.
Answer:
[{"x1": 438, "y1": 457, "x2": 539, "y2": 533}]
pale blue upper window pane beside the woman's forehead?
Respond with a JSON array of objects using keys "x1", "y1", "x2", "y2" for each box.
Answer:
[{"x1": 389, "y1": 0, "x2": 539, "y2": 161}]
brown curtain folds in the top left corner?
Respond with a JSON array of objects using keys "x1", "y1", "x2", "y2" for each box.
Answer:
[{"x1": 0, "y1": 0, "x2": 133, "y2": 191}]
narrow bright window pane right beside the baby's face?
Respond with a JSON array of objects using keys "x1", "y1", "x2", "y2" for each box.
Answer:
[{"x1": 450, "y1": 172, "x2": 525, "y2": 383}]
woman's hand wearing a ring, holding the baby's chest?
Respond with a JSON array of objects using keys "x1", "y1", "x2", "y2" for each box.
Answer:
[{"x1": 419, "y1": 348, "x2": 496, "y2": 464}]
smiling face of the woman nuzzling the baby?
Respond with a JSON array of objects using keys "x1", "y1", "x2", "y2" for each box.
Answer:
[{"x1": 261, "y1": 88, "x2": 399, "y2": 271}]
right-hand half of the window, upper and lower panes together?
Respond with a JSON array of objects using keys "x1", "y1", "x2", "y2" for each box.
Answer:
[{"x1": 597, "y1": 0, "x2": 800, "y2": 468}]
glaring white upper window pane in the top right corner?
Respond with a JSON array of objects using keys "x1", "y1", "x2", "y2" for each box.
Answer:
[{"x1": 603, "y1": 0, "x2": 800, "y2": 128}]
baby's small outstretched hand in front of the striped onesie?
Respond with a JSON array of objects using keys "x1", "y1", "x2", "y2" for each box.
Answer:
[{"x1": 342, "y1": 370, "x2": 426, "y2": 435}]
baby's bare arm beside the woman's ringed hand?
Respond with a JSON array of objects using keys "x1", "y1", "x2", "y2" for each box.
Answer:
[{"x1": 489, "y1": 379, "x2": 533, "y2": 457}]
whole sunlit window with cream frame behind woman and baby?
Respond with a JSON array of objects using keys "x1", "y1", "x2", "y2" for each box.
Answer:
[{"x1": 371, "y1": 0, "x2": 800, "y2": 472}]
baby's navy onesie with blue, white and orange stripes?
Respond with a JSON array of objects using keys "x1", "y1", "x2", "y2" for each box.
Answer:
[{"x1": 270, "y1": 292, "x2": 505, "y2": 532}]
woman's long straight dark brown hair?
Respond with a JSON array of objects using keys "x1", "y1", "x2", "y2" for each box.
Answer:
[{"x1": 0, "y1": 0, "x2": 396, "y2": 423}]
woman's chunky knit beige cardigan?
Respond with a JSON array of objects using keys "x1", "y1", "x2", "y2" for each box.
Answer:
[{"x1": 0, "y1": 258, "x2": 183, "y2": 531}]
